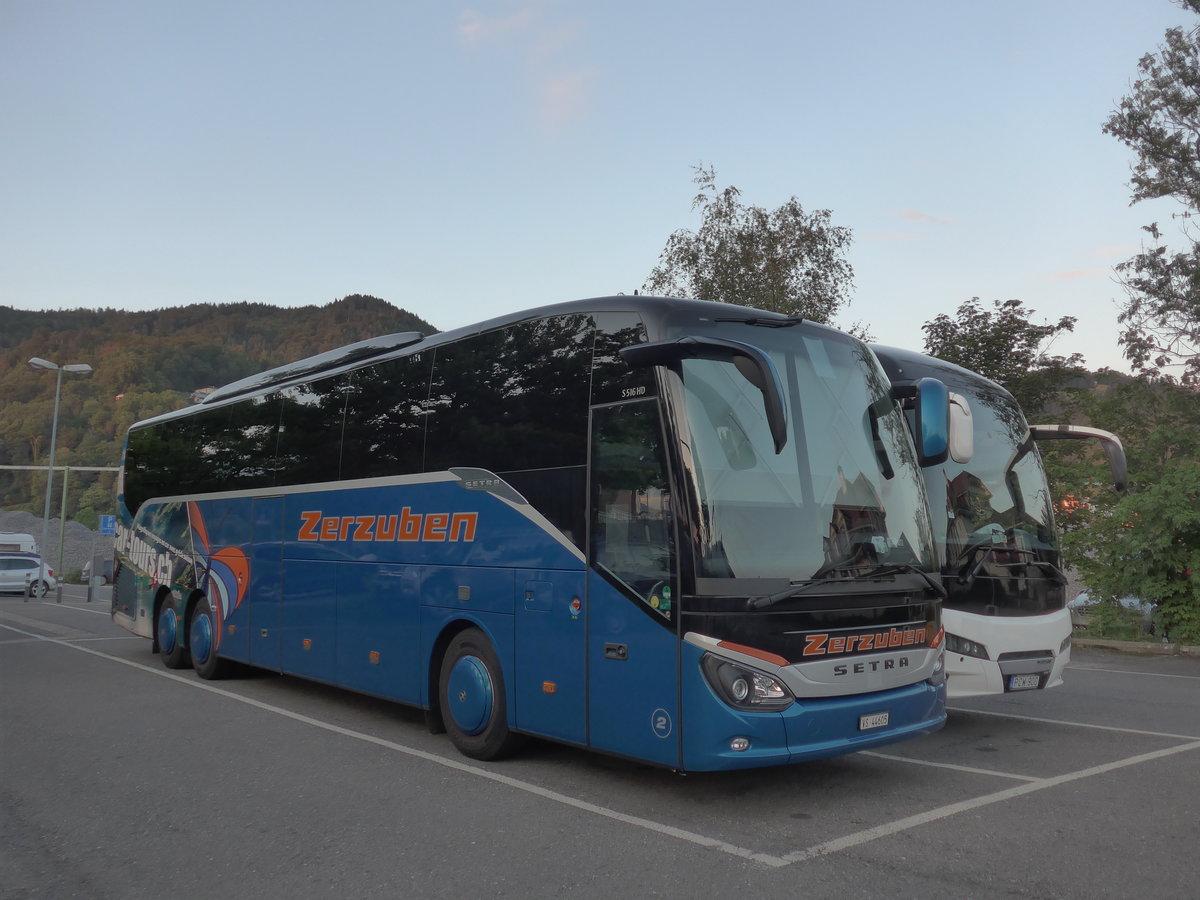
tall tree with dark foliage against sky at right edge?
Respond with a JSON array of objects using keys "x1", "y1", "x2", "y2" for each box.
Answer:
[{"x1": 1103, "y1": 0, "x2": 1200, "y2": 382}]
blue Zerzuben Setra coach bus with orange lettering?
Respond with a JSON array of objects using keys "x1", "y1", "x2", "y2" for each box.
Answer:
[{"x1": 113, "y1": 296, "x2": 947, "y2": 772}]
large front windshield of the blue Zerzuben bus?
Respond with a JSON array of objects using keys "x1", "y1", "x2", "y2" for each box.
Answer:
[{"x1": 674, "y1": 323, "x2": 936, "y2": 594}]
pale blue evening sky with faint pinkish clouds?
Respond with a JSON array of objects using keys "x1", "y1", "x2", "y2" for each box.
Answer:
[{"x1": 0, "y1": 0, "x2": 1195, "y2": 367}]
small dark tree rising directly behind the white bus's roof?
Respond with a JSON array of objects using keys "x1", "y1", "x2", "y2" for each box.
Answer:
[{"x1": 920, "y1": 296, "x2": 1082, "y2": 416}]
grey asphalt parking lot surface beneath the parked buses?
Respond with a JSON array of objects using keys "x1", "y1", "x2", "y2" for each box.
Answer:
[{"x1": 0, "y1": 589, "x2": 1200, "y2": 898}]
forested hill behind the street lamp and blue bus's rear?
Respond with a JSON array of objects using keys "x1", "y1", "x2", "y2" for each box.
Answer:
[{"x1": 0, "y1": 294, "x2": 438, "y2": 523}]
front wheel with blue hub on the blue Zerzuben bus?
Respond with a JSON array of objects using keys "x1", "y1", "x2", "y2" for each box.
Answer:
[{"x1": 438, "y1": 628, "x2": 523, "y2": 760}]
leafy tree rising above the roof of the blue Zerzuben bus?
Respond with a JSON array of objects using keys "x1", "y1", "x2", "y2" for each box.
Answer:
[{"x1": 643, "y1": 166, "x2": 854, "y2": 323}]
